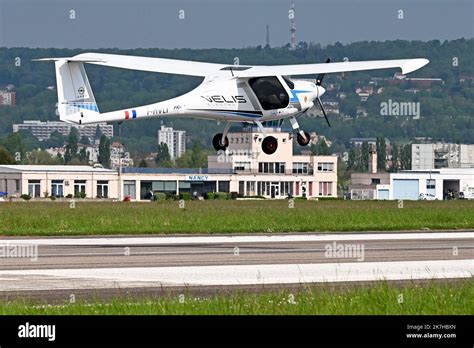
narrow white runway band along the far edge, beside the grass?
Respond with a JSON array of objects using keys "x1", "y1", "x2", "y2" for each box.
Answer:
[{"x1": 0, "y1": 232, "x2": 474, "y2": 246}]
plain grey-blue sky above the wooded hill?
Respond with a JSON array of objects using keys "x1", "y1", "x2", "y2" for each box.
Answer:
[{"x1": 0, "y1": 0, "x2": 474, "y2": 49}]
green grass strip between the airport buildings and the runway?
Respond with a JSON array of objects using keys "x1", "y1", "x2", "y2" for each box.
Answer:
[{"x1": 0, "y1": 200, "x2": 474, "y2": 235}]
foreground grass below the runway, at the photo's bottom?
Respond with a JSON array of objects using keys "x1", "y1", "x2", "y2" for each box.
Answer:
[{"x1": 0, "y1": 280, "x2": 474, "y2": 315}]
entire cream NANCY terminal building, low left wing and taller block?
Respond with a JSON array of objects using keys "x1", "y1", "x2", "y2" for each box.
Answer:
[{"x1": 0, "y1": 128, "x2": 337, "y2": 201}]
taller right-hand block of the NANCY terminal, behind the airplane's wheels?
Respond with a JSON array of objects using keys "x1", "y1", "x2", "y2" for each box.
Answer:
[{"x1": 208, "y1": 127, "x2": 337, "y2": 198}]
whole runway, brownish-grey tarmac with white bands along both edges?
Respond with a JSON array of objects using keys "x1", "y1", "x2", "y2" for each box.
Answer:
[{"x1": 0, "y1": 231, "x2": 474, "y2": 297}]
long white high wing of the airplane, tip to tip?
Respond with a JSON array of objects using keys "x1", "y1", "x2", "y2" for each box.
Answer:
[{"x1": 38, "y1": 53, "x2": 429, "y2": 77}]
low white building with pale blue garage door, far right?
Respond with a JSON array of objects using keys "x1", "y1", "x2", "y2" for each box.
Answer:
[{"x1": 376, "y1": 168, "x2": 474, "y2": 200}]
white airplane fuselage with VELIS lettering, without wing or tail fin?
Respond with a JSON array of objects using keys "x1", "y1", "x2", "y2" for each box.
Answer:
[{"x1": 65, "y1": 76, "x2": 324, "y2": 124}]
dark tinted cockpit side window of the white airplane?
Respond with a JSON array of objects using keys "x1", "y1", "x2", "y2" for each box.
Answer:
[{"x1": 249, "y1": 76, "x2": 290, "y2": 110}]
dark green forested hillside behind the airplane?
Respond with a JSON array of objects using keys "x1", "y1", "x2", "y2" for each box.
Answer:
[{"x1": 0, "y1": 39, "x2": 474, "y2": 153}]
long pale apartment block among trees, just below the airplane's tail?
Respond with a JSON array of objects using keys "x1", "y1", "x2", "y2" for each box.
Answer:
[{"x1": 13, "y1": 121, "x2": 114, "y2": 142}]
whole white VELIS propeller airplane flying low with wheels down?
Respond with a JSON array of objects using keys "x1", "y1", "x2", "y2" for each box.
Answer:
[{"x1": 38, "y1": 53, "x2": 429, "y2": 154}]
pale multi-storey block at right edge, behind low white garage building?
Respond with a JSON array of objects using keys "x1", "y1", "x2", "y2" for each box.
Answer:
[{"x1": 411, "y1": 143, "x2": 474, "y2": 170}]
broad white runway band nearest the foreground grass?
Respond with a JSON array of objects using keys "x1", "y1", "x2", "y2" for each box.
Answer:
[{"x1": 0, "y1": 260, "x2": 474, "y2": 291}]
